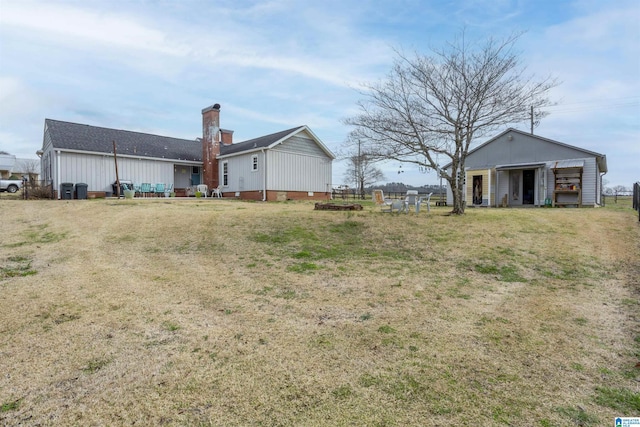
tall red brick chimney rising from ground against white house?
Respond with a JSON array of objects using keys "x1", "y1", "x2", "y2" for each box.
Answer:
[{"x1": 202, "y1": 104, "x2": 220, "y2": 189}]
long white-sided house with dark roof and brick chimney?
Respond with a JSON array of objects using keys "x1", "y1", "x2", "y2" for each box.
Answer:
[{"x1": 39, "y1": 104, "x2": 335, "y2": 201}]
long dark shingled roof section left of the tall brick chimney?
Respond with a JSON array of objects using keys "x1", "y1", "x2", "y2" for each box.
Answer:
[{"x1": 45, "y1": 119, "x2": 202, "y2": 162}]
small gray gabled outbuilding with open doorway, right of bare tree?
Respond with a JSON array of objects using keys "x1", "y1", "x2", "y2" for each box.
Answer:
[{"x1": 443, "y1": 129, "x2": 607, "y2": 207}]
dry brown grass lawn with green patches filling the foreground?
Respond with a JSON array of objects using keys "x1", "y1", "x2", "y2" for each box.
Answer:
[{"x1": 0, "y1": 198, "x2": 640, "y2": 426}]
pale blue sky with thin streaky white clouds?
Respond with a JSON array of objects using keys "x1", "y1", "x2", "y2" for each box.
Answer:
[{"x1": 0, "y1": 0, "x2": 640, "y2": 187}]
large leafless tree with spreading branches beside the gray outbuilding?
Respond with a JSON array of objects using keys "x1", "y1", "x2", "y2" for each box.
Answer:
[{"x1": 345, "y1": 32, "x2": 558, "y2": 214}]
